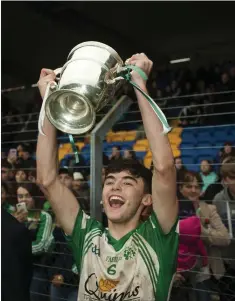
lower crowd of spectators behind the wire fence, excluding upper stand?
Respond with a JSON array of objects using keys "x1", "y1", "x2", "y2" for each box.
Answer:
[{"x1": 2, "y1": 139, "x2": 235, "y2": 301}]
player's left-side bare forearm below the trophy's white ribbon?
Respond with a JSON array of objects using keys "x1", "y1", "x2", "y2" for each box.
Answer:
[{"x1": 36, "y1": 117, "x2": 57, "y2": 187}]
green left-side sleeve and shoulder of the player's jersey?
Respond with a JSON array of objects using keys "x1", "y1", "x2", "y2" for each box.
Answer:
[{"x1": 66, "y1": 209, "x2": 103, "y2": 273}]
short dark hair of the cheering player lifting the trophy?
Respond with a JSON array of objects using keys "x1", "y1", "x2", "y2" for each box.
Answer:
[{"x1": 105, "y1": 159, "x2": 153, "y2": 193}]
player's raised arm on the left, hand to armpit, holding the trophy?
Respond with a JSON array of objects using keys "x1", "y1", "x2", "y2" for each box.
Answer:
[{"x1": 36, "y1": 69, "x2": 79, "y2": 234}]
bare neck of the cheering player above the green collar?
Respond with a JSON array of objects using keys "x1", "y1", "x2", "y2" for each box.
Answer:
[{"x1": 108, "y1": 218, "x2": 140, "y2": 240}]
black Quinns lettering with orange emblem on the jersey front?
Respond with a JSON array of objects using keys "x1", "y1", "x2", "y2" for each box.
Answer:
[{"x1": 84, "y1": 273, "x2": 140, "y2": 301}]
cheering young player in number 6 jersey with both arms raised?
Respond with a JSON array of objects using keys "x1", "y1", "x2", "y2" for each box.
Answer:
[{"x1": 37, "y1": 53, "x2": 178, "y2": 301}]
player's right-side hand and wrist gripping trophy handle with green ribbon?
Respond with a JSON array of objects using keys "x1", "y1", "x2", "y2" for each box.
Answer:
[{"x1": 126, "y1": 53, "x2": 153, "y2": 88}]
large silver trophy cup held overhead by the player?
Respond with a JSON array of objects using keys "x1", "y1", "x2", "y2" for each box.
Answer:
[{"x1": 45, "y1": 42, "x2": 123, "y2": 134}]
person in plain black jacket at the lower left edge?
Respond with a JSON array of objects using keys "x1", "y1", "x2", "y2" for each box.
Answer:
[{"x1": 1, "y1": 208, "x2": 33, "y2": 301}]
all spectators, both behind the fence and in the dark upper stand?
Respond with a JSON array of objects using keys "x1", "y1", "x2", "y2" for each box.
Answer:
[{"x1": 1, "y1": 64, "x2": 235, "y2": 301}]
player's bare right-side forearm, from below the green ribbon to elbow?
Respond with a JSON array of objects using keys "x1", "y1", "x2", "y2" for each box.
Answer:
[{"x1": 135, "y1": 87, "x2": 174, "y2": 170}]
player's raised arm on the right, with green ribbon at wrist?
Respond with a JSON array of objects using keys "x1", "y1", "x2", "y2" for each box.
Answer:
[{"x1": 128, "y1": 53, "x2": 178, "y2": 233}]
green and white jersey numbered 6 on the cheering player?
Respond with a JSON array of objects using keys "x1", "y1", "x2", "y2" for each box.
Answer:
[{"x1": 68, "y1": 210, "x2": 178, "y2": 301}]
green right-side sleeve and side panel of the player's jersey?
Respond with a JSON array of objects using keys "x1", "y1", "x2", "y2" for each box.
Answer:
[{"x1": 139, "y1": 212, "x2": 179, "y2": 301}]
